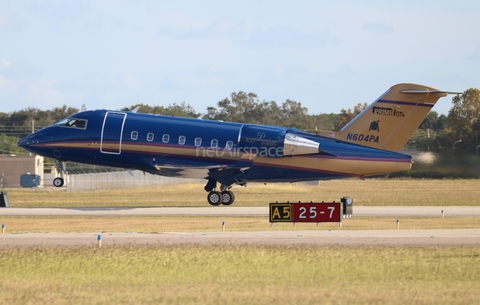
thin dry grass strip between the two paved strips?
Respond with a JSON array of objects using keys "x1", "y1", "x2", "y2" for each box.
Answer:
[{"x1": 0, "y1": 216, "x2": 480, "y2": 234}]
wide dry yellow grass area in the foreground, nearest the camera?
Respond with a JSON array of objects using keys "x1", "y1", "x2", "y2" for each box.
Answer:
[{"x1": 0, "y1": 246, "x2": 480, "y2": 304}]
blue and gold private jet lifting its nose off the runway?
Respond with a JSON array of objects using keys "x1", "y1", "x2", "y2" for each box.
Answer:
[{"x1": 18, "y1": 83, "x2": 459, "y2": 206}]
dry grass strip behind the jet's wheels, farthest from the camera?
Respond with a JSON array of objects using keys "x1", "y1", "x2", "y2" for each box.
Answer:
[{"x1": 7, "y1": 179, "x2": 480, "y2": 207}]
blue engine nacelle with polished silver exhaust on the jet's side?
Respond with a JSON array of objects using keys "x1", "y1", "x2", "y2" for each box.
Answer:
[{"x1": 239, "y1": 125, "x2": 320, "y2": 158}]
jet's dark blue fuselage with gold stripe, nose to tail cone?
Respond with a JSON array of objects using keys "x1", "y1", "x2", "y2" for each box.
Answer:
[{"x1": 18, "y1": 110, "x2": 411, "y2": 185}]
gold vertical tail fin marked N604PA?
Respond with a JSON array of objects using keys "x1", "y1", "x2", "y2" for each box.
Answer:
[{"x1": 335, "y1": 84, "x2": 456, "y2": 152}]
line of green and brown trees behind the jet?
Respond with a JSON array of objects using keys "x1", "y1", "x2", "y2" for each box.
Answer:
[{"x1": 0, "y1": 88, "x2": 480, "y2": 154}]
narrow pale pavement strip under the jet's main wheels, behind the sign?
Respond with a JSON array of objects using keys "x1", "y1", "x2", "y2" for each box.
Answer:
[{"x1": 0, "y1": 206, "x2": 480, "y2": 217}]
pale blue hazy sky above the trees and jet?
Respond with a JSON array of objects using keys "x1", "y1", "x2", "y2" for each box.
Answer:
[{"x1": 0, "y1": 0, "x2": 480, "y2": 114}]
